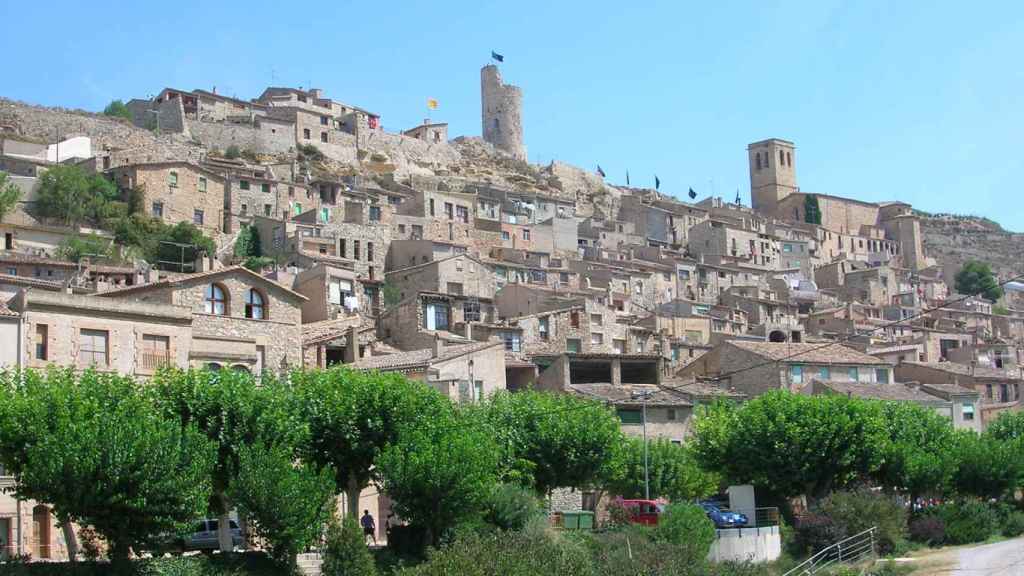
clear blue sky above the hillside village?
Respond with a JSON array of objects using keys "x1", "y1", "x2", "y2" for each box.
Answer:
[{"x1": 0, "y1": 0, "x2": 1024, "y2": 231}]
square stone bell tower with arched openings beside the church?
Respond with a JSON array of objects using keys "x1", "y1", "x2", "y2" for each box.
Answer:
[{"x1": 746, "y1": 138, "x2": 800, "y2": 214}]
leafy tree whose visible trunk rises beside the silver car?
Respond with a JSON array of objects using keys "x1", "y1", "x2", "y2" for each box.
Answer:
[{"x1": 150, "y1": 369, "x2": 304, "y2": 551}]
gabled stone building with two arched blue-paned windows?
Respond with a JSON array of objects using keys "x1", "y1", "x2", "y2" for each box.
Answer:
[{"x1": 97, "y1": 266, "x2": 306, "y2": 374}]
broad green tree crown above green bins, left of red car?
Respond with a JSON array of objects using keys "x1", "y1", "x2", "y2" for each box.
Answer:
[{"x1": 475, "y1": 392, "x2": 623, "y2": 494}]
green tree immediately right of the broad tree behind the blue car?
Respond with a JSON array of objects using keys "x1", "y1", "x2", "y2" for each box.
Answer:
[{"x1": 876, "y1": 402, "x2": 955, "y2": 501}]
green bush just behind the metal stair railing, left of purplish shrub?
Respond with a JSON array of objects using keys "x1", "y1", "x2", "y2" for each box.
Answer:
[{"x1": 817, "y1": 491, "x2": 906, "y2": 554}]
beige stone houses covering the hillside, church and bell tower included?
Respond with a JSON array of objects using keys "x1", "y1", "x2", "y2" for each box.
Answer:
[{"x1": 0, "y1": 78, "x2": 1024, "y2": 558}]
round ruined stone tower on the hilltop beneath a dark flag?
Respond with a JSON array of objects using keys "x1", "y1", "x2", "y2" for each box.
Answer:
[{"x1": 480, "y1": 65, "x2": 526, "y2": 160}]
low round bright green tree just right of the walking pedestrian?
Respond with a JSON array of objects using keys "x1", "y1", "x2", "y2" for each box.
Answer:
[{"x1": 377, "y1": 408, "x2": 498, "y2": 545}]
